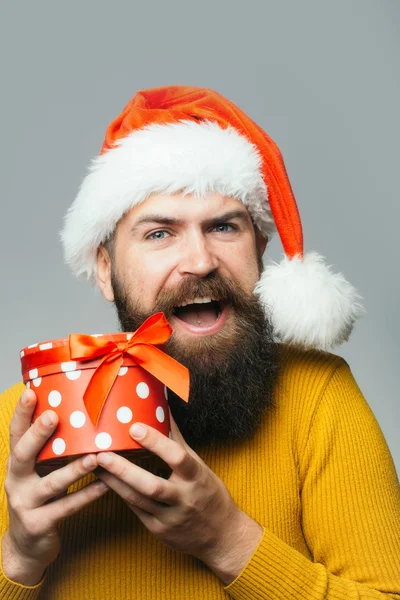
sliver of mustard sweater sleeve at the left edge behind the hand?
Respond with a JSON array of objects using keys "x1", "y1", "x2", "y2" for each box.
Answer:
[{"x1": 0, "y1": 384, "x2": 44, "y2": 600}]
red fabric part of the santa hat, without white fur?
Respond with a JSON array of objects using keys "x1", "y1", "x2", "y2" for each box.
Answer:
[{"x1": 102, "y1": 85, "x2": 303, "y2": 258}]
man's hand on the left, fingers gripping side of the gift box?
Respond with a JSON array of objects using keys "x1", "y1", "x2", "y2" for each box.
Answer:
[{"x1": 2, "y1": 389, "x2": 109, "y2": 585}]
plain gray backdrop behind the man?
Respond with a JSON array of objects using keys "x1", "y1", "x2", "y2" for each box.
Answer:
[{"x1": 0, "y1": 0, "x2": 400, "y2": 470}]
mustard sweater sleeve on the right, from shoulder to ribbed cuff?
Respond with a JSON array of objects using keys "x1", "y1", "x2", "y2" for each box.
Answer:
[{"x1": 225, "y1": 363, "x2": 400, "y2": 600}]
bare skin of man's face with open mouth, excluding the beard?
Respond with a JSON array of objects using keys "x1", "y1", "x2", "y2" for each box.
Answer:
[{"x1": 99, "y1": 193, "x2": 266, "y2": 346}]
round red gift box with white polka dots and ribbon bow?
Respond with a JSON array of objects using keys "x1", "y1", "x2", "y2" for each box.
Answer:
[{"x1": 21, "y1": 313, "x2": 189, "y2": 463}]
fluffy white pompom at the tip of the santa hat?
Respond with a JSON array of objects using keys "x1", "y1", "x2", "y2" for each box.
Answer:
[{"x1": 254, "y1": 252, "x2": 365, "y2": 350}]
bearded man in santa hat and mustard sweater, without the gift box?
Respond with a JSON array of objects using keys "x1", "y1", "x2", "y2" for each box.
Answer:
[{"x1": 0, "y1": 86, "x2": 400, "y2": 600}]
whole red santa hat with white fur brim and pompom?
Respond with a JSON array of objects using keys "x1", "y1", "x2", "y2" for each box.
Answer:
[{"x1": 61, "y1": 86, "x2": 364, "y2": 349}]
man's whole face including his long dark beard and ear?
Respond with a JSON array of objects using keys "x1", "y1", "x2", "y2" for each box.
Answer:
[{"x1": 98, "y1": 193, "x2": 276, "y2": 445}]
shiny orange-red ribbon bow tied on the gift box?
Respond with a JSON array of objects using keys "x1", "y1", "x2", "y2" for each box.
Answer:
[{"x1": 69, "y1": 312, "x2": 189, "y2": 426}]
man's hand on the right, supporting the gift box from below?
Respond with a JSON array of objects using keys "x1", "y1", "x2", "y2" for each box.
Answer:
[{"x1": 97, "y1": 415, "x2": 263, "y2": 584}]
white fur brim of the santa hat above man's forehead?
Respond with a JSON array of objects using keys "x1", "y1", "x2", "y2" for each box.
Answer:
[{"x1": 61, "y1": 121, "x2": 275, "y2": 282}]
